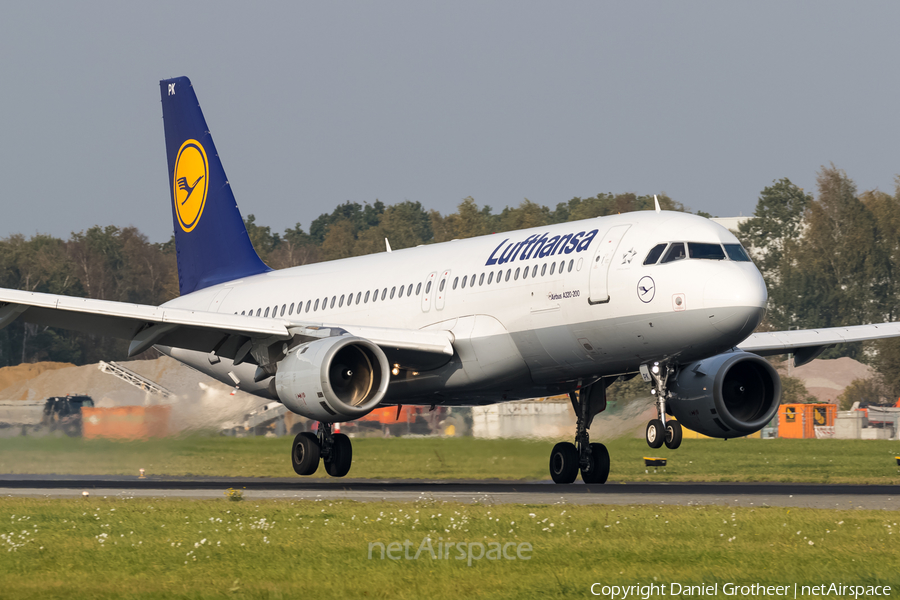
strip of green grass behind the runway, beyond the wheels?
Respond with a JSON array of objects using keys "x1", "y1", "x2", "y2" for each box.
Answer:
[{"x1": 0, "y1": 436, "x2": 900, "y2": 484}]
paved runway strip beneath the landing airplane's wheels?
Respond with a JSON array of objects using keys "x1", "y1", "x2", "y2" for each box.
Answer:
[{"x1": 0, "y1": 475, "x2": 900, "y2": 510}]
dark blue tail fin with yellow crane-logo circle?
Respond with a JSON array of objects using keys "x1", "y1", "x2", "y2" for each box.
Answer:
[{"x1": 159, "y1": 77, "x2": 271, "y2": 295}]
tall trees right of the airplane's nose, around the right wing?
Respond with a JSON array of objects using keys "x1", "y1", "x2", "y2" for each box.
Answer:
[{"x1": 738, "y1": 165, "x2": 900, "y2": 408}]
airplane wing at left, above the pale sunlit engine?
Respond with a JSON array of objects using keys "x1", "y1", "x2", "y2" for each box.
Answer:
[{"x1": 0, "y1": 289, "x2": 453, "y2": 366}]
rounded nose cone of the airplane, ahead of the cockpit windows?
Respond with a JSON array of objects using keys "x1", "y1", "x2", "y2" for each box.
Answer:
[{"x1": 703, "y1": 265, "x2": 768, "y2": 340}]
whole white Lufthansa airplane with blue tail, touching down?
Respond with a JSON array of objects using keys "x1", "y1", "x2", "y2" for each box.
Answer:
[{"x1": 0, "y1": 77, "x2": 900, "y2": 483}]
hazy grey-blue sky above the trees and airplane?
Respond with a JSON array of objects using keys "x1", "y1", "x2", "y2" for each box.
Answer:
[{"x1": 0, "y1": 0, "x2": 900, "y2": 241}]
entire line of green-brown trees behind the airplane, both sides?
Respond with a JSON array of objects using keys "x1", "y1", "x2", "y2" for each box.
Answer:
[{"x1": 0, "y1": 171, "x2": 900, "y2": 408}]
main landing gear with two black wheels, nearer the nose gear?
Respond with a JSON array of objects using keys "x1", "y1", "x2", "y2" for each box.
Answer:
[{"x1": 550, "y1": 379, "x2": 609, "y2": 483}]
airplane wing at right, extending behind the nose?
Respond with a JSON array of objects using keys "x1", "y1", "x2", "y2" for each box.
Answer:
[{"x1": 739, "y1": 323, "x2": 900, "y2": 367}]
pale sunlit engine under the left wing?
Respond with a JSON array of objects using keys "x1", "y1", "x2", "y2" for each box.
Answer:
[{"x1": 275, "y1": 336, "x2": 391, "y2": 423}]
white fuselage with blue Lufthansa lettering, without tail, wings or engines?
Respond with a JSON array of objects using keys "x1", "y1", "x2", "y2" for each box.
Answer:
[{"x1": 164, "y1": 211, "x2": 766, "y2": 404}]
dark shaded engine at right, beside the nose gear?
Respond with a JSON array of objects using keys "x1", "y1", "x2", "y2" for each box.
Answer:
[{"x1": 666, "y1": 352, "x2": 781, "y2": 438}]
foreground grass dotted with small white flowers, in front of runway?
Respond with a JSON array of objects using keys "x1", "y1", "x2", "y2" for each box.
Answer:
[{"x1": 0, "y1": 497, "x2": 900, "y2": 599}]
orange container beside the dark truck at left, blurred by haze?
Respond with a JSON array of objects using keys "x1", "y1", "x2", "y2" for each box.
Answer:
[{"x1": 81, "y1": 406, "x2": 171, "y2": 440}]
